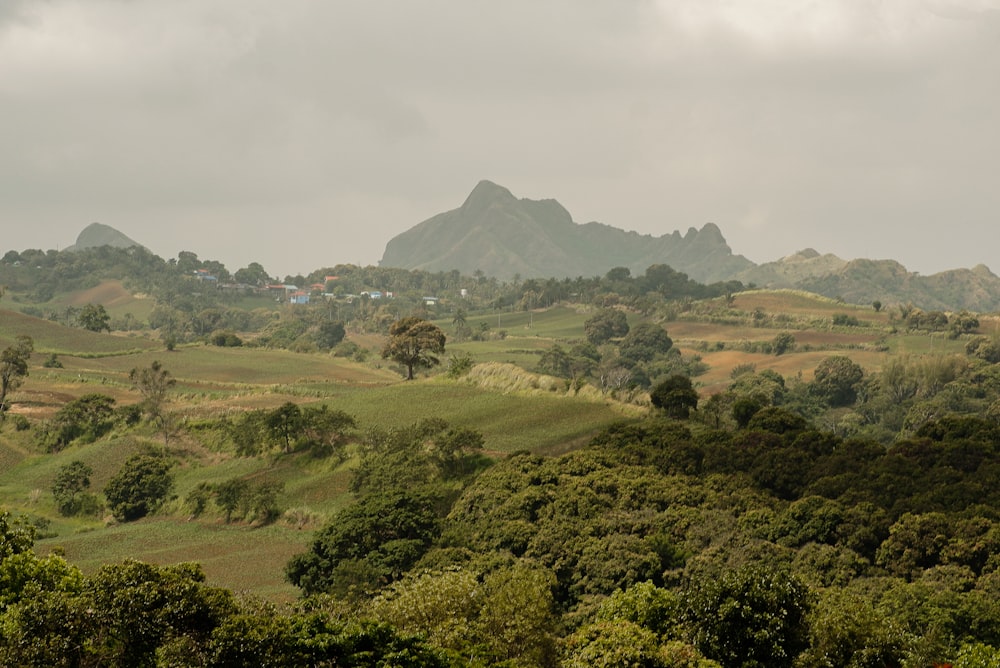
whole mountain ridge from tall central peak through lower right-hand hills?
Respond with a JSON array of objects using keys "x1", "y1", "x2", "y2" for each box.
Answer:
[{"x1": 379, "y1": 180, "x2": 1000, "y2": 311}]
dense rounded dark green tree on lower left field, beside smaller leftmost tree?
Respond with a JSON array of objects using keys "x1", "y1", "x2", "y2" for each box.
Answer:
[{"x1": 104, "y1": 454, "x2": 174, "y2": 522}]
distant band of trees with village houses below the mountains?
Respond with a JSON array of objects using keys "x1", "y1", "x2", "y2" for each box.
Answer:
[{"x1": 0, "y1": 246, "x2": 743, "y2": 355}]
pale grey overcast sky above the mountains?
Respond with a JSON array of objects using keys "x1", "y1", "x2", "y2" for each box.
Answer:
[{"x1": 0, "y1": 0, "x2": 1000, "y2": 276}]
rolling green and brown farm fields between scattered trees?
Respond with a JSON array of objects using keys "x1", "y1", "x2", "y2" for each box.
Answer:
[{"x1": 0, "y1": 284, "x2": 984, "y2": 600}]
